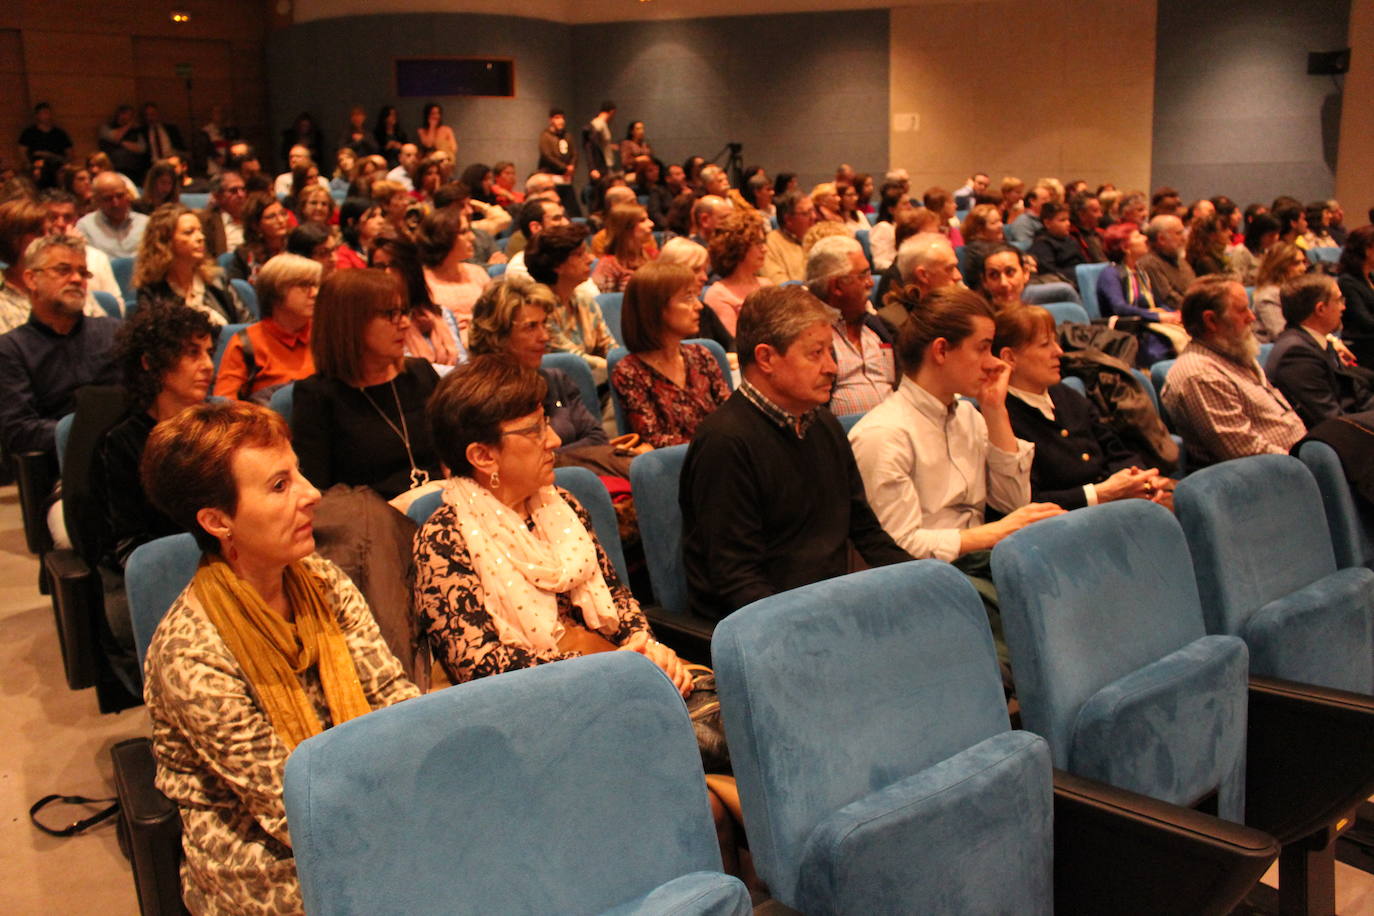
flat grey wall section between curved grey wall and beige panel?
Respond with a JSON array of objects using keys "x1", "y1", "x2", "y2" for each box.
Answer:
[{"x1": 573, "y1": 10, "x2": 889, "y2": 190}]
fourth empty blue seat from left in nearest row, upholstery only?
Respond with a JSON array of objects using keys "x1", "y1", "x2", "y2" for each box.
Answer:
[{"x1": 1173, "y1": 455, "x2": 1374, "y2": 694}]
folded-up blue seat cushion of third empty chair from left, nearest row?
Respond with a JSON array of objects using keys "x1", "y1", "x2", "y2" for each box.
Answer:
[{"x1": 1068, "y1": 636, "x2": 1249, "y2": 823}]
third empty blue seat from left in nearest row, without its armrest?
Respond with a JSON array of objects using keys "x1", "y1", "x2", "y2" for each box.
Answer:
[{"x1": 992, "y1": 500, "x2": 1249, "y2": 821}]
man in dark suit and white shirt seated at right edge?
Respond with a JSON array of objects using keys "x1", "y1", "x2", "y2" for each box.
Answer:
[{"x1": 1264, "y1": 273, "x2": 1374, "y2": 430}]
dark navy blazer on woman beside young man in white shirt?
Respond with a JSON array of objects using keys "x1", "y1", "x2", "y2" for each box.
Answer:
[{"x1": 1007, "y1": 383, "x2": 1151, "y2": 509}]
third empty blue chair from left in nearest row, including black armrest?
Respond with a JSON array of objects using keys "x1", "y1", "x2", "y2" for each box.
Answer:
[{"x1": 992, "y1": 500, "x2": 1374, "y2": 915}]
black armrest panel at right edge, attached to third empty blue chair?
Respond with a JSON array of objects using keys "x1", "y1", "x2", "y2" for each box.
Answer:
[{"x1": 1245, "y1": 677, "x2": 1374, "y2": 845}]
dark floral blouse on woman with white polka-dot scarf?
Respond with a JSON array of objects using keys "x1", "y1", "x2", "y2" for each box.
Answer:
[{"x1": 415, "y1": 489, "x2": 649, "y2": 684}]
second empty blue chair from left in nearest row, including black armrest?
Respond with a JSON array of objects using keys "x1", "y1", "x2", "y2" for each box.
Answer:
[{"x1": 712, "y1": 560, "x2": 1278, "y2": 915}]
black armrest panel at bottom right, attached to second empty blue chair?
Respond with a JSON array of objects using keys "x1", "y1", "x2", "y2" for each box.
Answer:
[{"x1": 1054, "y1": 769, "x2": 1279, "y2": 915}]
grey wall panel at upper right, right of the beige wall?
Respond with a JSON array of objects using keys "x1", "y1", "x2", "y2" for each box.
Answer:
[{"x1": 1153, "y1": 0, "x2": 1351, "y2": 205}]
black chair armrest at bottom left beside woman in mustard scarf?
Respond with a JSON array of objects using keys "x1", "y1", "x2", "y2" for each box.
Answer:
[{"x1": 110, "y1": 737, "x2": 187, "y2": 916}]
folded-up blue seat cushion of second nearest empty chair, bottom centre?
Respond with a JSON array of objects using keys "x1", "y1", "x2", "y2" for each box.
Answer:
[{"x1": 797, "y1": 732, "x2": 1054, "y2": 916}]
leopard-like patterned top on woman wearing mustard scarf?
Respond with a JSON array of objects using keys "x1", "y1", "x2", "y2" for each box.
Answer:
[{"x1": 143, "y1": 556, "x2": 419, "y2": 916}]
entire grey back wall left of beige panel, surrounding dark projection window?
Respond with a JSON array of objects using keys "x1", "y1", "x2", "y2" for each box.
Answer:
[{"x1": 268, "y1": 10, "x2": 888, "y2": 188}]
